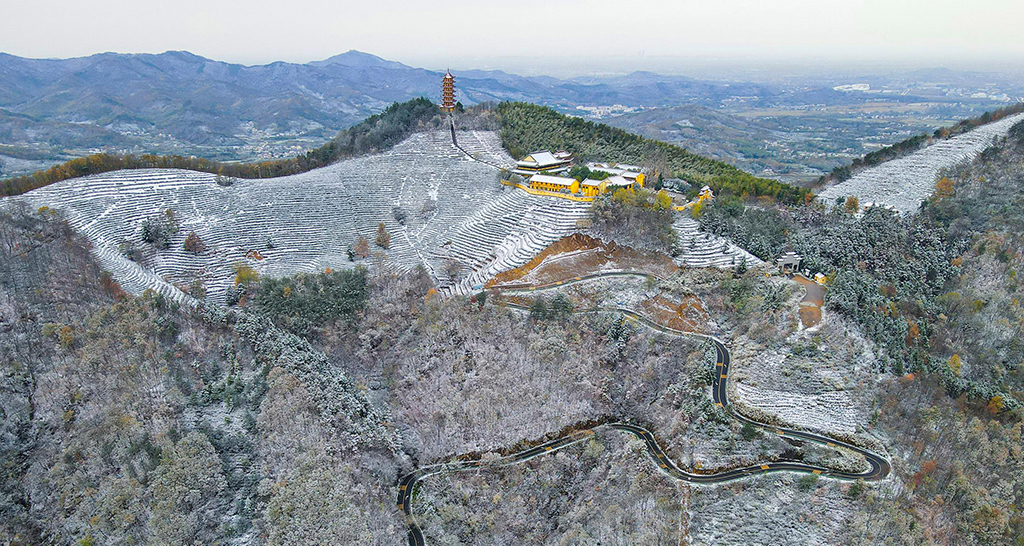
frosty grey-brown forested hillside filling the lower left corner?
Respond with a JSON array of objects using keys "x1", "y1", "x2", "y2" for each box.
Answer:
[{"x1": 0, "y1": 202, "x2": 404, "y2": 545}]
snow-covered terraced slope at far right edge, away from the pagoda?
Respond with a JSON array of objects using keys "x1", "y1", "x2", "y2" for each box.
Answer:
[{"x1": 818, "y1": 114, "x2": 1024, "y2": 212}]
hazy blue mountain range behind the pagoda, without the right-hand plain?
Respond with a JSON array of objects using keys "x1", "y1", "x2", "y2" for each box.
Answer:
[{"x1": 0, "y1": 51, "x2": 864, "y2": 159}]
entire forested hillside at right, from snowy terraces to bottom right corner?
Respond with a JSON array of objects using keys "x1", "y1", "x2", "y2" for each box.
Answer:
[{"x1": 700, "y1": 118, "x2": 1024, "y2": 545}]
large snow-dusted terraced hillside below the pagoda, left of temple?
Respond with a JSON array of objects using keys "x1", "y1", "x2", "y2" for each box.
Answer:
[{"x1": 8, "y1": 131, "x2": 589, "y2": 301}]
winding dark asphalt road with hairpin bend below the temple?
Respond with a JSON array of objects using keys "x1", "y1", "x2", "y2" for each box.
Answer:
[{"x1": 398, "y1": 271, "x2": 891, "y2": 546}]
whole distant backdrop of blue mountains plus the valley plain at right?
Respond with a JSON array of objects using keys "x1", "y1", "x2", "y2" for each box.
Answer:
[{"x1": 0, "y1": 50, "x2": 1011, "y2": 180}]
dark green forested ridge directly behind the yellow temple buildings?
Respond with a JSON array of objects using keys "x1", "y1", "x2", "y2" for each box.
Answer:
[{"x1": 498, "y1": 102, "x2": 809, "y2": 203}]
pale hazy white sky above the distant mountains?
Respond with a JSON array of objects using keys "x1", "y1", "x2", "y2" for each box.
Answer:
[{"x1": 0, "y1": 0, "x2": 1024, "y2": 72}]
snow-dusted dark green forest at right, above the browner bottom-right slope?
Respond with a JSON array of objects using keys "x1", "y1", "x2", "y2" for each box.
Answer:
[{"x1": 700, "y1": 116, "x2": 1024, "y2": 412}]
